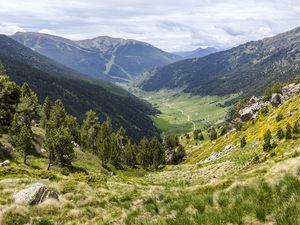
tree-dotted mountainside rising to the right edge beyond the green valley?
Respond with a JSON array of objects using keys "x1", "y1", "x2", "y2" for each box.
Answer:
[{"x1": 138, "y1": 27, "x2": 300, "y2": 96}]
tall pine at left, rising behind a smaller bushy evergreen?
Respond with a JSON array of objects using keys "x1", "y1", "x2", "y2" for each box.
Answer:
[{"x1": 17, "y1": 83, "x2": 39, "y2": 129}]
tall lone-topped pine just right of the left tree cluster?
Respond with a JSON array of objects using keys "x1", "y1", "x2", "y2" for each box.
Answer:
[{"x1": 80, "y1": 110, "x2": 101, "y2": 152}]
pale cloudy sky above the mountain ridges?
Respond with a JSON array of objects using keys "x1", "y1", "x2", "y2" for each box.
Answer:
[{"x1": 0, "y1": 0, "x2": 300, "y2": 51}]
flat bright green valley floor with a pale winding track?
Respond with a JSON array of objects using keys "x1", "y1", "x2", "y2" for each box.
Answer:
[{"x1": 131, "y1": 89, "x2": 237, "y2": 135}]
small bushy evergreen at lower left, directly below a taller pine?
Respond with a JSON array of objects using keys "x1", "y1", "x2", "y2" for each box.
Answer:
[{"x1": 17, "y1": 125, "x2": 33, "y2": 164}]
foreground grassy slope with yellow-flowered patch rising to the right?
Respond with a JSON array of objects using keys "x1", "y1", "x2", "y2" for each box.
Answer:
[{"x1": 0, "y1": 95, "x2": 300, "y2": 225}]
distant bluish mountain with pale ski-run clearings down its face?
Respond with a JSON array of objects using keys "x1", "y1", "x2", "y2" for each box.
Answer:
[{"x1": 11, "y1": 32, "x2": 181, "y2": 82}]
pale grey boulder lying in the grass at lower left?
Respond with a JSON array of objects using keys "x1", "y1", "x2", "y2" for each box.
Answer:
[{"x1": 14, "y1": 183, "x2": 58, "y2": 205}]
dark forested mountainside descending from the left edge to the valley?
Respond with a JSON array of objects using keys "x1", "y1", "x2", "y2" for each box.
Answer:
[{"x1": 0, "y1": 35, "x2": 158, "y2": 140}]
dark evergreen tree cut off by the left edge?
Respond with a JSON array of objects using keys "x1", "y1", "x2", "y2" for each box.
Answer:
[{"x1": 0, "y1": 67, "x2": 20, "y2": 131}]
